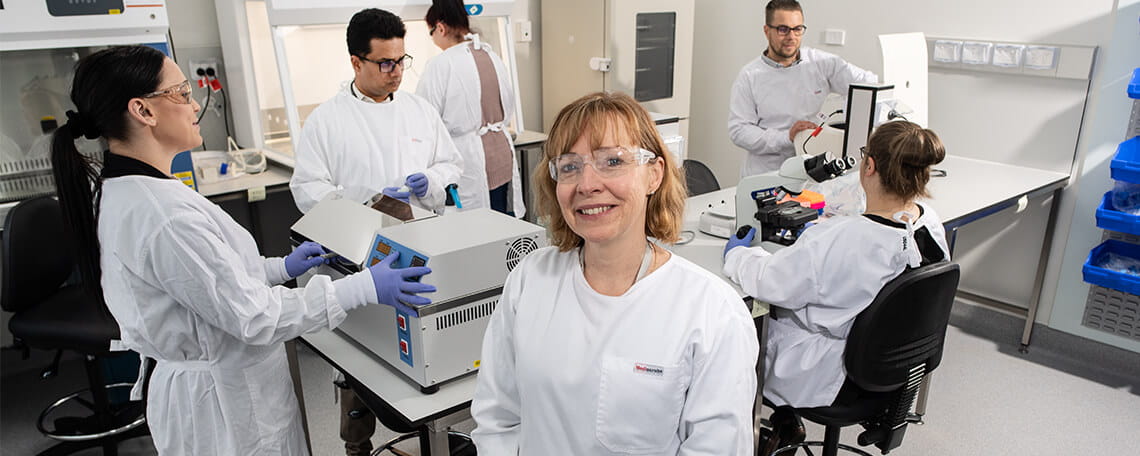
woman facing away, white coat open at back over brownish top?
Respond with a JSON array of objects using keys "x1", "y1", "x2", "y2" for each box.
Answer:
[{"x1": 416, "y1": 0, "x2": 527, "y2": 218}]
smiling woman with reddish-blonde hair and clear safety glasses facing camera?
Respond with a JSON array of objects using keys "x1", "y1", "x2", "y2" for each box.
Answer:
[{"x1": 471, "y1": 92, "x2": 759, "y2": 456}]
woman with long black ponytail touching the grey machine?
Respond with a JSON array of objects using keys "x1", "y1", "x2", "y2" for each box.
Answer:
[{"x1": 51, "y1": 47, "x2": 432, "y2": 455}]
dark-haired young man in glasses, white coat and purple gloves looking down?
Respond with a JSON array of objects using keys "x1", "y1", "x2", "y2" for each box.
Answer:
[{"x1": 290, "y1": 8, "x2": 462, "y2": 212}]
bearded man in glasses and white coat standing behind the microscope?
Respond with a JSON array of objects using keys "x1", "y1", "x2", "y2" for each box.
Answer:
[{"x1": 728, "y1": 0, "x2": 879, "y2": 177}]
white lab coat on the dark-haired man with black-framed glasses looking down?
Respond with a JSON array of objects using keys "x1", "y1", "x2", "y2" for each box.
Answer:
[{"x1": 290, "y1": 88, "x2": 463, "y2": 212}]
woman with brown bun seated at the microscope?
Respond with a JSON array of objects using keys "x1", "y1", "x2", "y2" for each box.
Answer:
[{"x1": 724, "y1": 121, "x2": 950, "y2": 454}]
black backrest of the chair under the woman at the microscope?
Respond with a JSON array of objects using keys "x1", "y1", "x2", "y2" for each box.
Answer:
[{"x1": 844, "y1": 262, "x2": 961, "y2": 392}]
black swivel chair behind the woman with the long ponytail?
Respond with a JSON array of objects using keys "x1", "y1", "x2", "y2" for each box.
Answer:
[{"x1": 0, "y1": 196, "x2": 149, "y2": 456}]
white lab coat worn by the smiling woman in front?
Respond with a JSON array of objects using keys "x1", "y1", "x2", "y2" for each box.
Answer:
[{"x1": 471, "y1": 247, "x2": 759, "y2": 456}]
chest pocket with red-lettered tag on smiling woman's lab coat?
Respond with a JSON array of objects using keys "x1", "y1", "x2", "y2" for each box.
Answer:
[{"x1": 595, "y1": 356, "x2": 691, "y2": 454}]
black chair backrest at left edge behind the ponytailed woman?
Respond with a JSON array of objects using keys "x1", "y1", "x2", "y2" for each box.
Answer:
[{"x1": 0, "y1": 196, "x2": 75, "y2": 312}]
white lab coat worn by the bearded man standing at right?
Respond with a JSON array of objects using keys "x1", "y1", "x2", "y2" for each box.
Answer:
[{"x1": 728, "y1": 47, "x2": 879, "y2": 177}]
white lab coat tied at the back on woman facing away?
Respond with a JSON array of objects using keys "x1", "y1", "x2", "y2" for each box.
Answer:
[{"x1": 416, "y1": 41, "x2": 527, "y2": 218}]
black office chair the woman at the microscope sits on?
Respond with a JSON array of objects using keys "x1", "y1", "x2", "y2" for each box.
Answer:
[{"x1": 773, "y1": 262, "x2": 960, "y2": 456}]
